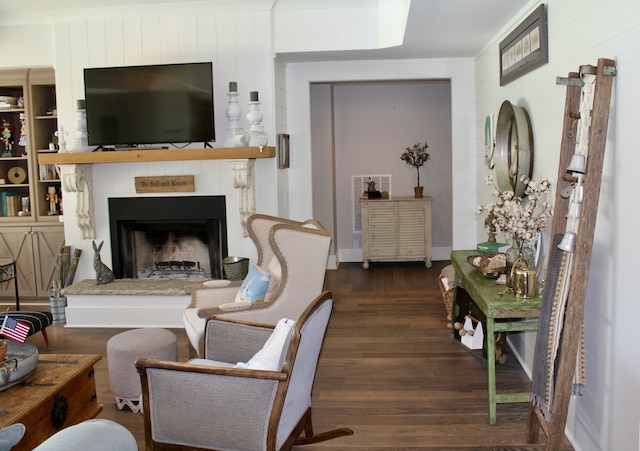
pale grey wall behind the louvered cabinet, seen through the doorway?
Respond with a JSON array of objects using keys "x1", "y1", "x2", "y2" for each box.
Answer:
[{"x1": 311, "y1": 80, "x2": 452, "y2": 262}]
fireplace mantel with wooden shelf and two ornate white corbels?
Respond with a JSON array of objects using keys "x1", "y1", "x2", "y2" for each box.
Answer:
[{"x1": 38, "y1": 147, "x2": 275, "y2": 240}]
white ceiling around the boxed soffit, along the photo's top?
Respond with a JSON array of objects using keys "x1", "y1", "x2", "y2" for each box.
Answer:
[{"x1": 0, "y1": 0, "x2": 531, "y2": 62}]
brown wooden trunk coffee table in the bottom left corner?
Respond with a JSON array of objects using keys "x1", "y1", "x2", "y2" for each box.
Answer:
[{"x1": 0, "y1": 354, "x2": 102, "y2": 451}]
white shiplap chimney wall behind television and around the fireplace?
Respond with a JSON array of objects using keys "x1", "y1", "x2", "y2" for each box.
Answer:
[{"x1": 48, "y1": 5, "x2": 282, "y2": 280}]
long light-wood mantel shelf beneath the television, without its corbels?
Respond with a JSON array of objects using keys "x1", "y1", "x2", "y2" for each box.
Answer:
[{"x1": 38, "y1": 147, "x2": 276, "y2": 164}]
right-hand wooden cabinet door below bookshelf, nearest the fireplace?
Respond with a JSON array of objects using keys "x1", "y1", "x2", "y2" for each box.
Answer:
[{"x1": 32, "y1": 226, "x2": 64, "y2": 297}]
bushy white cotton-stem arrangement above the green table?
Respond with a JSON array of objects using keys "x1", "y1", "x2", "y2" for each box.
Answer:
[{"x1": 478, "y1": 175, "x2": 553, "y2": 243}]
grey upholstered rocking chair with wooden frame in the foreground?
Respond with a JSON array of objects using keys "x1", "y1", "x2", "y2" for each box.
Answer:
[{"x1": 136, "y1": 292, "x2": 353, "y2": 450}]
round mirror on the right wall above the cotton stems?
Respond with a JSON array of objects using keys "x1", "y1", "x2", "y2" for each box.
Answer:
[{"x1": 494, "y1": 100, "x2": 533, "y2": 197}]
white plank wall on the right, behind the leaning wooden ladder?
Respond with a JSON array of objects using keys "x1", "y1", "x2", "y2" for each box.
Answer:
[{"x1": 476, "y1": 0, "x2": 640, "y2": 451}]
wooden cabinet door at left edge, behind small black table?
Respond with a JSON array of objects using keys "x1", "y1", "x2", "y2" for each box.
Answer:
[{"x1": 0, "y1": 227, "x2": 37, "y2": 299}]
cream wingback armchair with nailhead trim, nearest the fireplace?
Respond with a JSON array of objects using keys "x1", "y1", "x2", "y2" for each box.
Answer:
[{"x1": 183, "y1": 215, "x2": 331, "y2": 357}]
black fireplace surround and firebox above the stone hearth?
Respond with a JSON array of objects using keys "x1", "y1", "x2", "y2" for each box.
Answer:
[{"x1": 109, "y1": 196, "x2": 227, "y2": 279}]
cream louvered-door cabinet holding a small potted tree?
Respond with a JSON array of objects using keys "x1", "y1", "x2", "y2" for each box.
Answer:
[{"x1": 360, "y1": 197, "x2": 431, "y2": 269}]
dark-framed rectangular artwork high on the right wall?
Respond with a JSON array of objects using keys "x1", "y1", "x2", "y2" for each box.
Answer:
[{"x1": 500, "y1": 3, "x2": 549, "y2": 86}]
